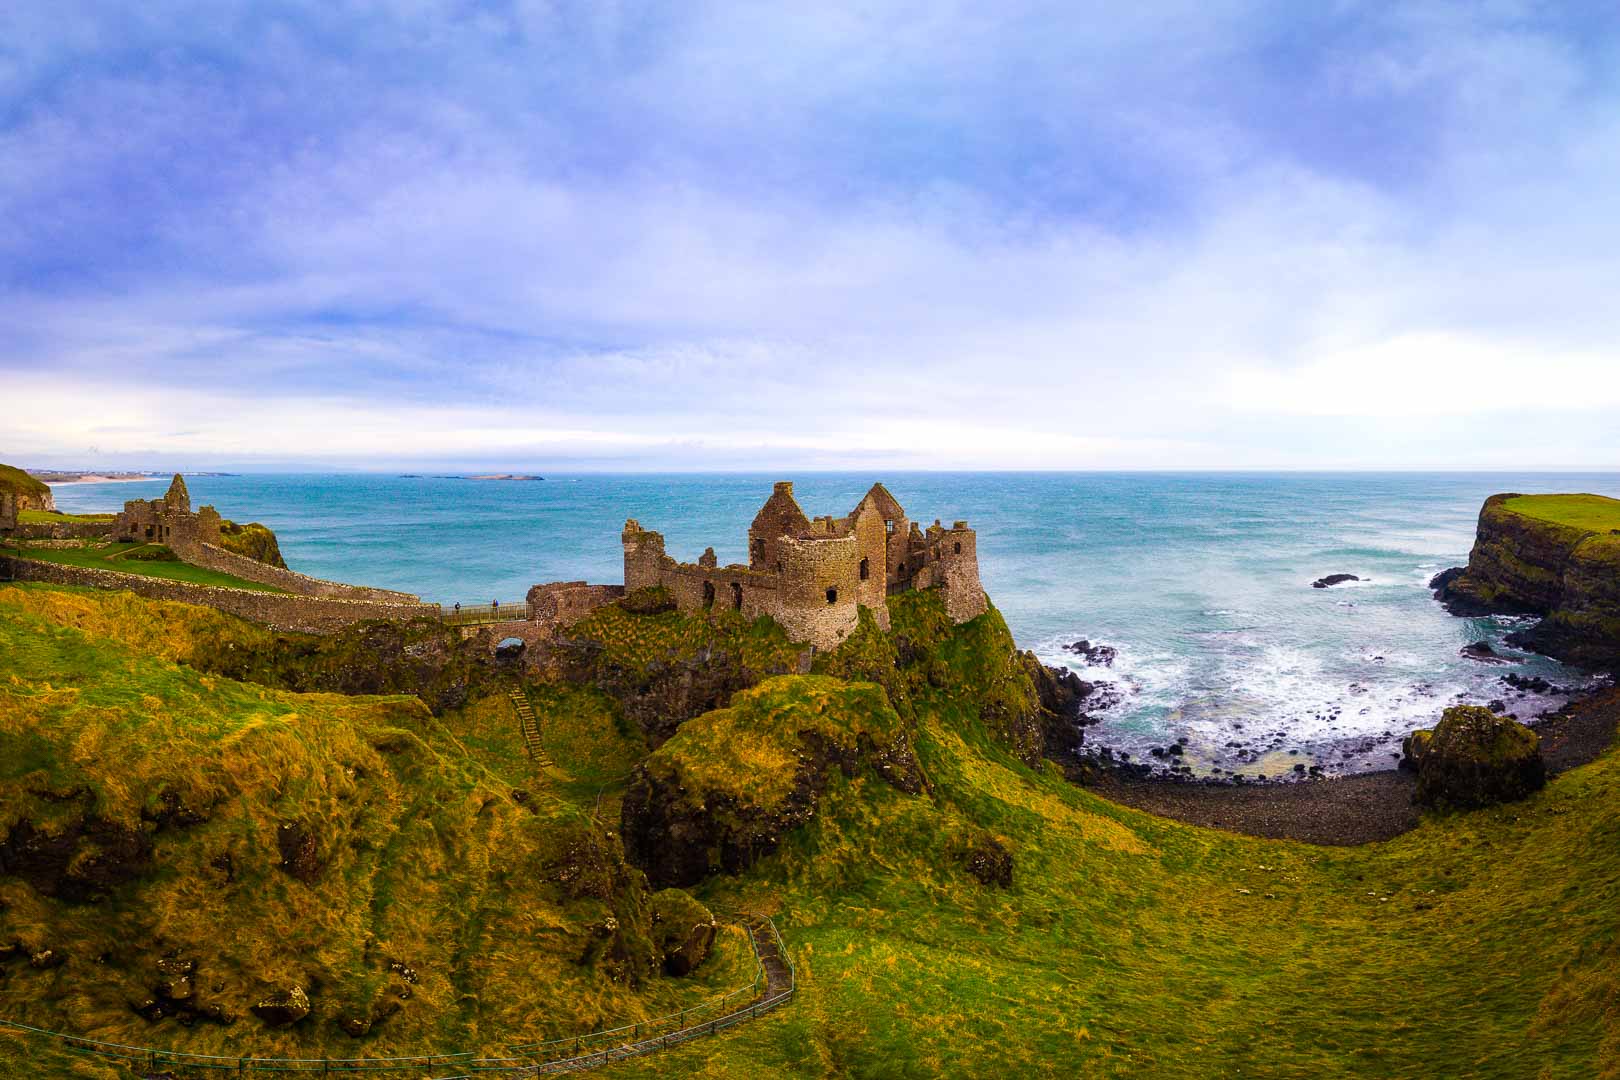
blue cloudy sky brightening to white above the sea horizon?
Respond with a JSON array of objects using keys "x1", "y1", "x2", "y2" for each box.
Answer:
[{"x1": 0, "y1": 0, "x2": 1620, "y2": 470}]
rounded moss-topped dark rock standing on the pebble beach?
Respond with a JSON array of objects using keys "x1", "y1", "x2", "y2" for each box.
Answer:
[{"x1": 1403, "y1": 704, "x2": 1547, "y2": 810}]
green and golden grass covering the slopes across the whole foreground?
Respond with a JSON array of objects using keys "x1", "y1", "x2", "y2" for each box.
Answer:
[{"x1": 0, "y1": 588, "x2": 1620, "y2": 1080}]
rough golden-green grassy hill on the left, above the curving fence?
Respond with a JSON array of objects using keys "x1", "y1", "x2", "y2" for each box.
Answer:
[{"x1": 0, "y1": 586, "x2": 753, "y2": 1075}]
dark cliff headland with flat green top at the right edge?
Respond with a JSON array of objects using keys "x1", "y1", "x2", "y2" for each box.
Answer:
[{"x1": 1434, "y1": 494, "x2": 1620, "y2": 669}]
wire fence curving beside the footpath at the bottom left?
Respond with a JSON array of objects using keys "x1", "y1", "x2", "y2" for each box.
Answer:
[{"x1": 0, "y1": 915, "x2": 797, "y2": 1080}]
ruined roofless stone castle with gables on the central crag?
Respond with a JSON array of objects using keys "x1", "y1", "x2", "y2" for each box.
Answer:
[{"x1": 622, "y1": 481, "x2": 987, "y2": 649}]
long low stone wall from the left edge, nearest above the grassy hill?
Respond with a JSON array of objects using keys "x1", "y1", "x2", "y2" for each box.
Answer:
[{"x1": 0, "y1": 555, "x2": 439, "y2": 633}]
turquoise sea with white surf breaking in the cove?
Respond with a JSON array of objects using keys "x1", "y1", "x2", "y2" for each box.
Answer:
[{"x1": 55, "y1": 473, "x2": 1620, "y2": 776}]
